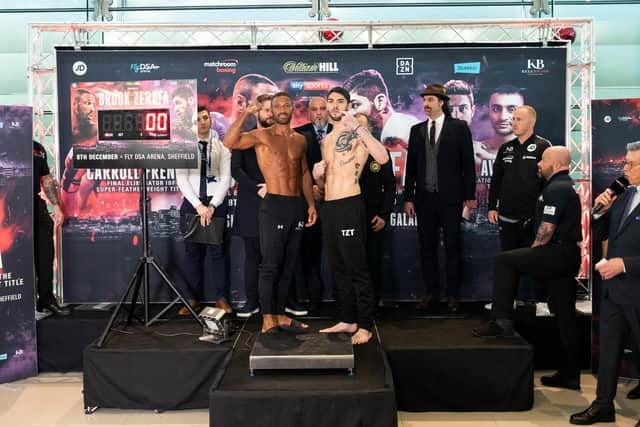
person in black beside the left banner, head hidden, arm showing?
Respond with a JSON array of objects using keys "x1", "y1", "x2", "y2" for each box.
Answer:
[{"x1": 33, "y1": 141, "x2": 71, "y2": 316}]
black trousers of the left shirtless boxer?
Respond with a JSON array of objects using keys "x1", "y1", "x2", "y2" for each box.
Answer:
[{"x1": 258, "y1": 194, "x2": 305, "y2": 314}]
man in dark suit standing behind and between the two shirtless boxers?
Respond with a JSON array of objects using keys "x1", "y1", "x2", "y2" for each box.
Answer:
[{"x1": 294, "y1": 97, "x2": 333, "y2": 311}]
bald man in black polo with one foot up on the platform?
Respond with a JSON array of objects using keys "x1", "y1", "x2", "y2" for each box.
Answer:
[{"x1": 473, "y1": 147, "x2": 582, "y2": 390}]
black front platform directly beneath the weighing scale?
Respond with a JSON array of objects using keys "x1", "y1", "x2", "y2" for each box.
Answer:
[{"x1": 209, "y1": 320, "x2": 398, "y2": 427}]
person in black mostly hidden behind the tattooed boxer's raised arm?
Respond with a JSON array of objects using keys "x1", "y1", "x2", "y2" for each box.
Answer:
[{"x1": 354, "y1": 113, "x2": 396, "y2": 306}]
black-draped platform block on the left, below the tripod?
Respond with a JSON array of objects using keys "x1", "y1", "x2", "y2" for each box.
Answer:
[{"x1": 83, "y1": 319, "x2": 232, "y2": 412}]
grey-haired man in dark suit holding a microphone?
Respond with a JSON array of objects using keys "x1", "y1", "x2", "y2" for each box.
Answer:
[{"x1": 570, "y1": 141, "x2": 640, "y2": 426}]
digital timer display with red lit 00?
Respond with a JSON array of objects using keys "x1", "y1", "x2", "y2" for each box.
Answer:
[{"x1": 98, "y1": 108, "x2": 171, "y2": 141}]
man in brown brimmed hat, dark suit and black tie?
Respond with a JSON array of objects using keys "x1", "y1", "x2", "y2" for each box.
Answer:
[{"x1": 404, "y1": 84, "x2": 477, "y2": 313}]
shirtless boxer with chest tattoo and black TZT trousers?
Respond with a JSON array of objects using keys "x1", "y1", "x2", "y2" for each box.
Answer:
[{"x1": 313, "y1": 87, "x2": 389, "y2": 344}]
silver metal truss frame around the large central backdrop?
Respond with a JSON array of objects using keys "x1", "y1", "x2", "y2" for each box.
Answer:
[{"x1": 28, "y1": 18, "x2": 595, "y2": 290}]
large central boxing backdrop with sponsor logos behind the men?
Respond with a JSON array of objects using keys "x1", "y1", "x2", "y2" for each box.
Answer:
[{"x1": 57, "y1": 45, "x2": 566, "y2": 302}]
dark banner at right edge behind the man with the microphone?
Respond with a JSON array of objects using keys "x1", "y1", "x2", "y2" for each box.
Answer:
[{"x1": 591, "y1": 98, "x2": 640, "y2": 377}]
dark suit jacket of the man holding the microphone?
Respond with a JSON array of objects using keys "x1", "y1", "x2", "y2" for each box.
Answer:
[{"x1": 599, "y1": 186, "x2": 640, "y2": 306}]
